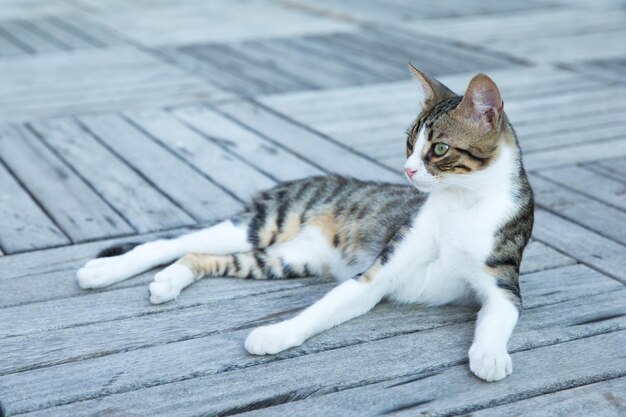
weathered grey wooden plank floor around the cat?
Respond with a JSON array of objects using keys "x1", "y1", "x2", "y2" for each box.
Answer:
[{"x1": 0, "y1": 0, "x2": 626, "y2": 417}]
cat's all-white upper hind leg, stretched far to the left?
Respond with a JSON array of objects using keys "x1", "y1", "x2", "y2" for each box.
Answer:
[{"x1": 76, "y1": 220, "x2": 252, "y2": 288}]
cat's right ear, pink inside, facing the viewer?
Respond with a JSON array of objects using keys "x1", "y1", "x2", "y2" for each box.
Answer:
[{"x1": 455, "y1": 74, "x2": 504, "y2": 131}]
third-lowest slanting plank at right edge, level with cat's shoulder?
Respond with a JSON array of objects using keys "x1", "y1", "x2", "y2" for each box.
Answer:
[{"x1": 539, "y1": 161, "x2": 626, "y2": 211}]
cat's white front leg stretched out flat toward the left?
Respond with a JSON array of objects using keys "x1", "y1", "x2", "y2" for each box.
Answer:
[{"x1": 245, "y1": 272, "x2": 387, "y2": 355}]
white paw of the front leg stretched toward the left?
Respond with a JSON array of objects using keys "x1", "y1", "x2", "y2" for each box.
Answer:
[{"x1": 245, "y1": 321, "x2": 305, "y2": 355}]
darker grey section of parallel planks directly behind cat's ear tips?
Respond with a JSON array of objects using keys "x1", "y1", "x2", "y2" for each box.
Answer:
[{"x1": 163, "y1": 28, "x2": 517, "y2": 96}]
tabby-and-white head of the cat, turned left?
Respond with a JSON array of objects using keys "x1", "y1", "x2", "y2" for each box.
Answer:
[{"x1": 404, "y1": 65, "x2": 511, "y2": 192}]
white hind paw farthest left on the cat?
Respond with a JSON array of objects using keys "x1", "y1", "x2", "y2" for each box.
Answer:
[{"x1": 76, "y1": 255, "x2": 135, "y2": 289}]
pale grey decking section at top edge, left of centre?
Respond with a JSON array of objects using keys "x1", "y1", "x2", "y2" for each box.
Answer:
[{"x1": 85, "y1": 0, "x2": 352, "y2": 46}]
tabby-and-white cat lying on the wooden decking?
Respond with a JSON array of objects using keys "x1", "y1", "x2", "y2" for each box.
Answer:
[{"x1": 77, "y1": 65, "x2": 533, "y2": 381}]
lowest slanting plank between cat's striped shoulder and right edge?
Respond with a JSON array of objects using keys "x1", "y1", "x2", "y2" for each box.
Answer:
[{"x1": 533, "y1": 210, "x2": 626, "y2": 283}]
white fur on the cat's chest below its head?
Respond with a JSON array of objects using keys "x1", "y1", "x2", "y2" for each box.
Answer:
[{"x1": 389, "y1": 148, "x2": 515, "y2": 305}]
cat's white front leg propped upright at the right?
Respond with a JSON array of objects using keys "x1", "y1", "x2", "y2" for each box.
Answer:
[{"x1": 469, "y1": 283, "x2": 519, "y2": 382}]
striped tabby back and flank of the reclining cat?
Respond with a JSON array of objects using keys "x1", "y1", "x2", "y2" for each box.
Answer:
[{"x1": 245, "y1": 175, "x2": 427, "y2": 254}]
